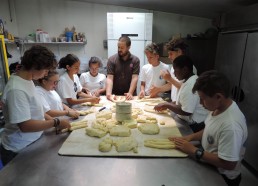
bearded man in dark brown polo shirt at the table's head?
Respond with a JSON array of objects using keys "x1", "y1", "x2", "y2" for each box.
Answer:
[{"x1": 106, "y1": 36, "x2": 140, "y2": 100}]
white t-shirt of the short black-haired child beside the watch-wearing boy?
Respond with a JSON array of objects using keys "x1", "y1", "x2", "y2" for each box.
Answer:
[{"x1": 176, "y1": 75, "x2": 208, "y2": 124}]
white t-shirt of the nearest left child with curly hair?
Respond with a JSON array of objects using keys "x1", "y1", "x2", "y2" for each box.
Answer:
[{"x1": 2, "y1": 74, "x2": 45, "y2": 152}]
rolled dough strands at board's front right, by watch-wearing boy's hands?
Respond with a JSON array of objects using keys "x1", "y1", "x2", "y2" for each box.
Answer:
[{"x1": 144, "y1": 138, "x2": 175, "y2": 149}]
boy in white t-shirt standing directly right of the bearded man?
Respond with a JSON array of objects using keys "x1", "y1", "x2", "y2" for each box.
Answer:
[{"x1": 138, "y1": 43, "x2": 169, "y2": 98}]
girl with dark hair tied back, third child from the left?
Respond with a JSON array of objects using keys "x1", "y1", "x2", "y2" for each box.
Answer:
[{"x1": 57, "y1": 54, "x2": 100, "y2": 105}]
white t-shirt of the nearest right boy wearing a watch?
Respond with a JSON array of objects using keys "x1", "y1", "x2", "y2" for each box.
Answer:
[{"x1": 202, "y1": 102, "x2": 248, "y2": 179}]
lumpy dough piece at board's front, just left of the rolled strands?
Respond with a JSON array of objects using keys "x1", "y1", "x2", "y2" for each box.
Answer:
[{"x1": 113, "y1": 137, "x2": 138, "y2": 153}]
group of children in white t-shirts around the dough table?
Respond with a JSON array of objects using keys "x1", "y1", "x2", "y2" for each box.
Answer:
[{"x1": 0, "y1": 40, "x2": 247, "y2": 185}]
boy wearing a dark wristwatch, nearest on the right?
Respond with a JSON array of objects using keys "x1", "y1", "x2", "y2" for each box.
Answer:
[{"x1": 169, "y1": 71, "x2": 247, "y2": 186}]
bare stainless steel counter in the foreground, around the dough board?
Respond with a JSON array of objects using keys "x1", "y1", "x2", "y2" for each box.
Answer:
[{"x1": 0, "y1": 114, "x2": 226, "y2": 186}]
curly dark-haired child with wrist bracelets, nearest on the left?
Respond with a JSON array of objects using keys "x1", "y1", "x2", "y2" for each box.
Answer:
[{"x1": 0, "y1": 45, "x2": 70, "y2": 165}]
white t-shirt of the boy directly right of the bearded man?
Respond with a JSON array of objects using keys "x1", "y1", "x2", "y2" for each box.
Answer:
[{"x1": 140, "y1": 62, "x2": 169, "y2": 96}]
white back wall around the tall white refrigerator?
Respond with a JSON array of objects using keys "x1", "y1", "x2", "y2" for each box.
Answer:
[{"x1": 0, "y1": 0, "x2": 211, "y2": 69}]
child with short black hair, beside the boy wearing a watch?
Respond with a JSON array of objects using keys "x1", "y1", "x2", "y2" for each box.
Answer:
[{"x1": 154, "y1": 55, "x2": 208, "y2": 132}]
